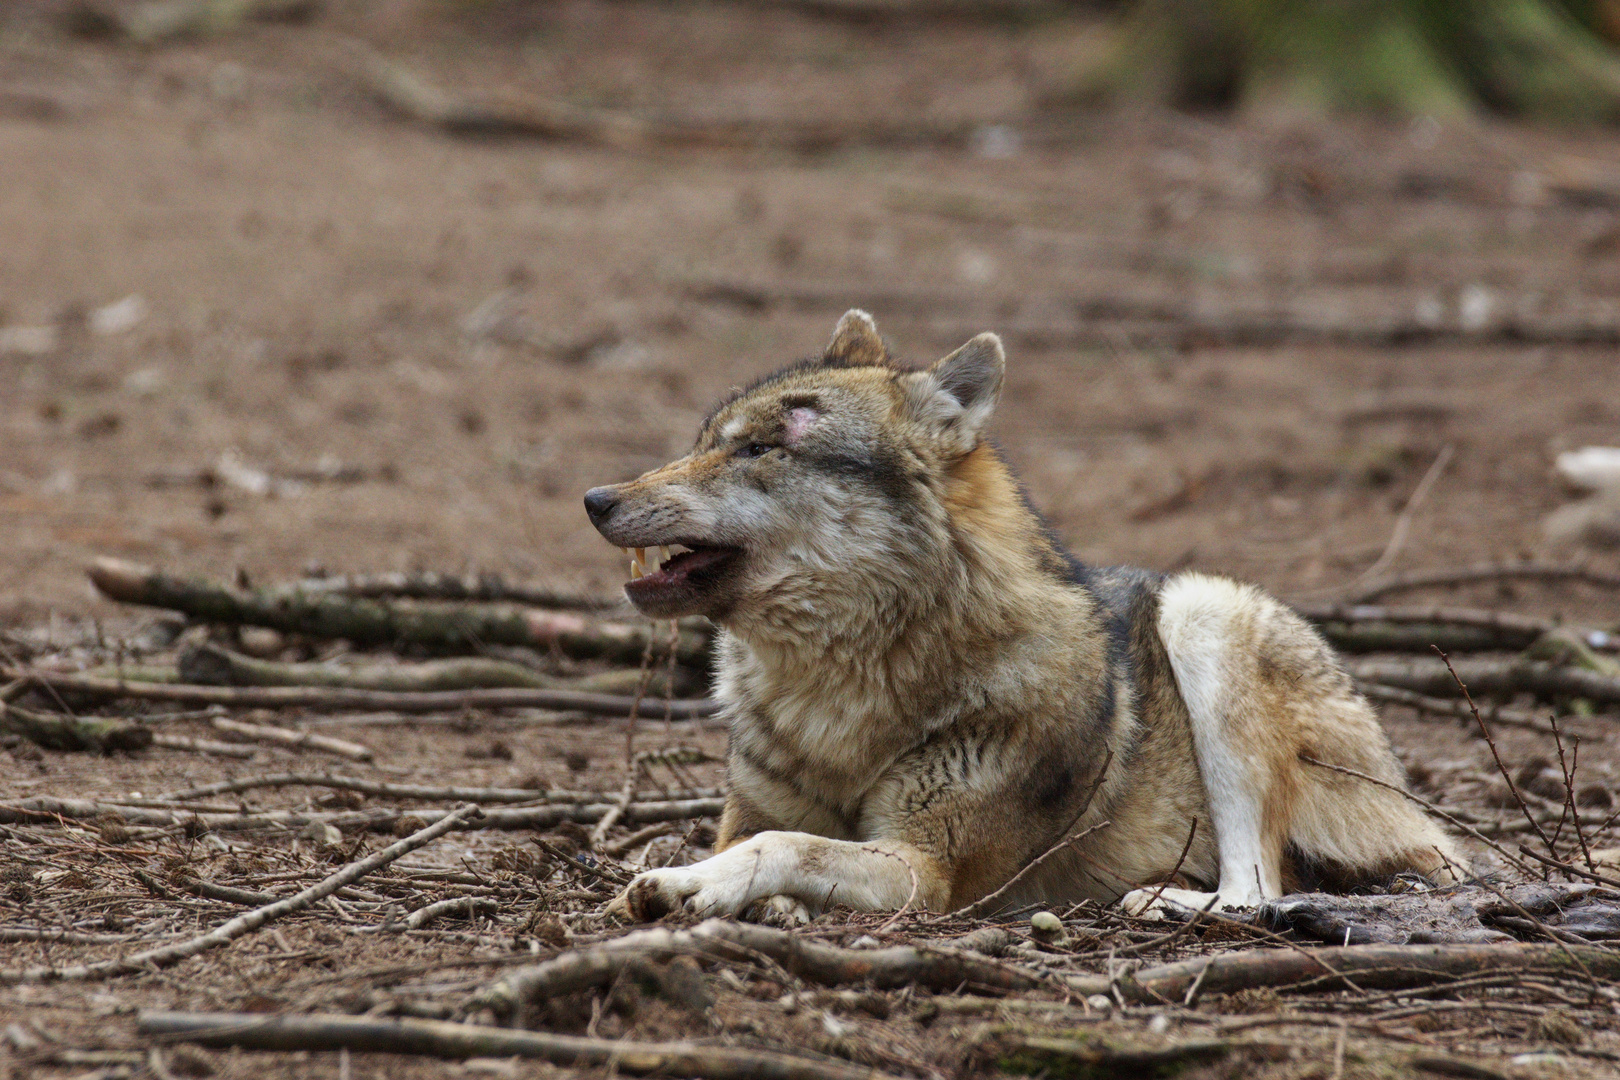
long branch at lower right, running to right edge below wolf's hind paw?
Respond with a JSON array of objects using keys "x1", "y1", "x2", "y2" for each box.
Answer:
[{"x1": 1064, "y1": 944, "x2": 1620, "y2": 1004}]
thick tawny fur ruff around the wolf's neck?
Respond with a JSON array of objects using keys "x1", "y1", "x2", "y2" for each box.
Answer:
[{"x1": 719, "y1": 444, "x2": 1087, "y2": 733}]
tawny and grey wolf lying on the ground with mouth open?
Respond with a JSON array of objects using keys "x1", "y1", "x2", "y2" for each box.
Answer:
[{"x1": 585, "y1": 309, "x2": 1460, "y2": 920}]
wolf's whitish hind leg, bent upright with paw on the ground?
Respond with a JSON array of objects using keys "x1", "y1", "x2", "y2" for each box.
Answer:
[{"x1": 1123, "y1": 576, "x2": 1288, "y2": 915}]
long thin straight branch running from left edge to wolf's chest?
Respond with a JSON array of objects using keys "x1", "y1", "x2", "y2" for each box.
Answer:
[{"x1": 0, "y1": 670, "x2": 719, "y2": 719}]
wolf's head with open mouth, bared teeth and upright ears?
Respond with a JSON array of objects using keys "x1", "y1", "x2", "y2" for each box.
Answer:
[{"x1": 585, "y1": 311, "x2": 1004, "y2": 623}]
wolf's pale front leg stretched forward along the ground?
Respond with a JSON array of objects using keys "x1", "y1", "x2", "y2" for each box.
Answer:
[{"x1": 608, "y1": 831, "x2": 949, "y2": 920}]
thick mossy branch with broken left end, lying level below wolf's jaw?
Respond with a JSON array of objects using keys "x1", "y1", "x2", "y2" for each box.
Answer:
[{"x1": 87, "y1": 559, "x2": 710, "y2": 667}]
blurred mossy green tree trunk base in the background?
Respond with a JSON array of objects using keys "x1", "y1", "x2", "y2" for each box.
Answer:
[{"x1": 1076, "y1": 0, "x2": 1620, "y2": 121}]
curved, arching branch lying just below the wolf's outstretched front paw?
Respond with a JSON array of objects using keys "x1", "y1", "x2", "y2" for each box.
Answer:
[{"x1": 470, "y1": 918, "x2": 1043, "y2": 1023}]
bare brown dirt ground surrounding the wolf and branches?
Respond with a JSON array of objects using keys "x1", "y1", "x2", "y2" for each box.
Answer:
[{"x1": 9, "y1": 0, "x2": 1620, "y2": 1078}]
